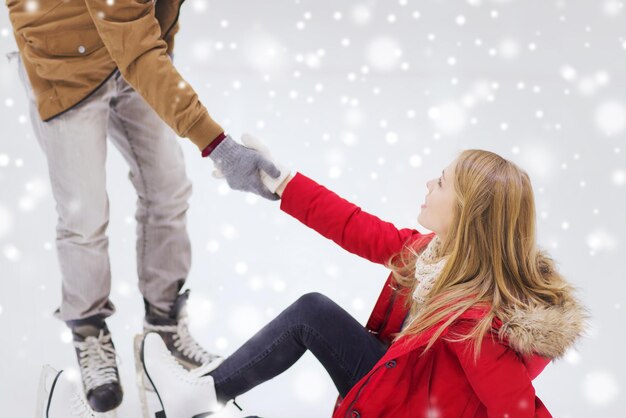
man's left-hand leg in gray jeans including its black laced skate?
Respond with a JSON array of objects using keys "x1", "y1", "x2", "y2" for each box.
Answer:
[{"x1": 18, "y1": 56, "x2": 122, "y2": 411}]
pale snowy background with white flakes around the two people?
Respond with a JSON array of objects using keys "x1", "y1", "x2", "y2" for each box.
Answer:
[{"x1": 0, "y1": 0, "x2": 626, "y2": 418}]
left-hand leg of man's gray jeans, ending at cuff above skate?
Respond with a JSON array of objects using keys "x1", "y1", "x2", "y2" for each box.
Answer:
[{"x1": 19, "y1": 63, "x2": 114, "y2": 322}]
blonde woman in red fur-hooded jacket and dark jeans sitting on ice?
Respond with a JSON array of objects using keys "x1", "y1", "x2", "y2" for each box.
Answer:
[{"x1": 144, "y1": 150, "x2": 586, "y2": 418}]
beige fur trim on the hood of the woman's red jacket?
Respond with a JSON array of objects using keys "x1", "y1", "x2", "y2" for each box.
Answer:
[{"x1": 499, "y1": 289, "x2": 589, "y2": 359}]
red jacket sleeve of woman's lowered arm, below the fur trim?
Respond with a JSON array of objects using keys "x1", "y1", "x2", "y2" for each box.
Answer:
[{"x1": 448, "y1": 327, "x2": 551, "y2": 418}]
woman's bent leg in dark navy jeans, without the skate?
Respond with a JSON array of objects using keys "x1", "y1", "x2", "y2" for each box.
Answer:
[{"x1": 210, "y1": 293, "x2": 387, "y2": 402}]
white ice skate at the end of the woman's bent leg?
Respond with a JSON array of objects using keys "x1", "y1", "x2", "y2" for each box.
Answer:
[{"x1": 138, "y1": 332, "x2": 222, "y2": 418}]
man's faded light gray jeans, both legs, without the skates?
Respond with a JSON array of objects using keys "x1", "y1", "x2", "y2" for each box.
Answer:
[{"x1": 18, "y1": 54, "x2": 192, "y2": 323}]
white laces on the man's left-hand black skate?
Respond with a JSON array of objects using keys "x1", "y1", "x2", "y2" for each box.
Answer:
[{"x1": 74, "y1": 330, "x2": 118, "y2": 392}]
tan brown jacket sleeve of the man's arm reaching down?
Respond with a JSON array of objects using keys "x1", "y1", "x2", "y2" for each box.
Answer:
[{"x1": 85, "y1": 0, "x2": 223, "y2": 150}]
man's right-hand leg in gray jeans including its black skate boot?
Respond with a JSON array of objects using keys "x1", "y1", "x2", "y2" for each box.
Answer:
[{"x1": 109, "y1": 77, "x2": 221, "y2": 369}]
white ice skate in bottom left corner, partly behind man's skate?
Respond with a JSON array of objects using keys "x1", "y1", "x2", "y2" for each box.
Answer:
[{"x1": 36, "y1": 365, "x2": 116, "y2": 418}]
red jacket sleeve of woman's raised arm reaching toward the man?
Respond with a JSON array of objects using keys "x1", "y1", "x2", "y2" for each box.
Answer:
[{"x1": 280, "y1": 173, "x2": 421, "y2": 264}]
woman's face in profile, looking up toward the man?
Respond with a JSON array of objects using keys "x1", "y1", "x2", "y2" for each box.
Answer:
[{"x1": 417, "y1": 161, "x2": 456, "y2": 238}]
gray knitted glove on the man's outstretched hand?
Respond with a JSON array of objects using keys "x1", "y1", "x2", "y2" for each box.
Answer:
[{"x1": 209, "y1": 135, "x2": 280, "y2": 200}]
